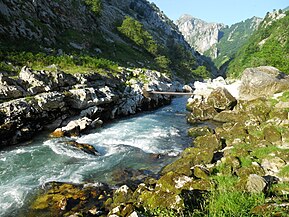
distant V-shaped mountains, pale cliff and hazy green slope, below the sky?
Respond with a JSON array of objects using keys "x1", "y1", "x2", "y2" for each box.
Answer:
[{"x1": 176, "y1": 15, "x2": 262, "y2": 67}]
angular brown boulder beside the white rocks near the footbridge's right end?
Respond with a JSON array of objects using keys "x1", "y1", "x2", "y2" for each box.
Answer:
[{"x1": 207, "y1": 87, "x2": 237, "y2": 111}]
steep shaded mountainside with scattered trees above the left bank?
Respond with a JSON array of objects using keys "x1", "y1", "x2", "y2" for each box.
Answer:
[{"x1": 0, "y1": 0, "x2": 209, "y2": 79}]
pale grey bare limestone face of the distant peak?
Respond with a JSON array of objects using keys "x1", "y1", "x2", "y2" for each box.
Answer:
[{"x1": 176, "y1": 15, "x2": 226, "y2": 54}]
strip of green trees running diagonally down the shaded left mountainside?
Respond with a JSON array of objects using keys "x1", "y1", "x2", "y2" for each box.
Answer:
[{"x1": 117, "y1": 16, "x2": 210, "y2": 79}]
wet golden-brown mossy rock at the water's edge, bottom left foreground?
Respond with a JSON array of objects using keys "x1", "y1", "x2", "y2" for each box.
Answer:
[{"x1": 28, "y1": 182, "x2": 112, "y2": 216}]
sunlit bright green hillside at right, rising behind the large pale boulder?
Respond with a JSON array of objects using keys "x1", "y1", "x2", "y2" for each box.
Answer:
[{"x1": 228, "y1": 11, "x2": 289, "y2": 77}]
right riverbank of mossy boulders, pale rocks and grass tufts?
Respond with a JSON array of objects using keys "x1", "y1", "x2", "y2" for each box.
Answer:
[{"x1": 6, "y1": 67, "x2": 289, "y2": 217}]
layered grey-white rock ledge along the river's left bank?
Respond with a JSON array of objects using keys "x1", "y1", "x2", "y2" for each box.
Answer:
[{"x1": 0, "y1": 67, "x2": 182, "y2": 147}]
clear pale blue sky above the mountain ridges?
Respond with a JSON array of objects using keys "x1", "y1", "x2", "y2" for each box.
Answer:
[{"x1": 149, "y1": 0, "x2": 289, "y2": 25}]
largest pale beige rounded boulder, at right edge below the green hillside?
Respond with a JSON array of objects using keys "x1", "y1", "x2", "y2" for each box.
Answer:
[{"x1": 240, "y1": 66, "x2": 289, "y2": 99}]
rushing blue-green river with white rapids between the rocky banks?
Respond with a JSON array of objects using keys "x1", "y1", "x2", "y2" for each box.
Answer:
[{"x1": 0, "y1": 97, "x2": 194, "y2": 216}]
